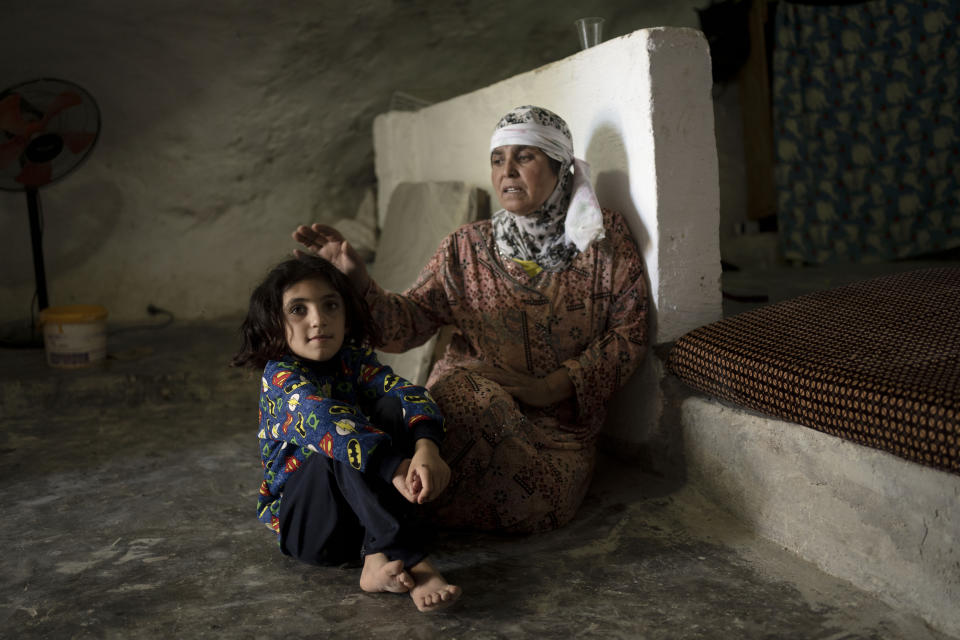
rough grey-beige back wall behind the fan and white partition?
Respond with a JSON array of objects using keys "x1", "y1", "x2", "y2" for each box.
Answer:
[{"x1": 0, "y1": 0, "x2": 712, "y2": 324}]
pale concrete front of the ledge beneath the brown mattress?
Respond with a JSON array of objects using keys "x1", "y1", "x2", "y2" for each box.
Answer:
[{"x1": 665, "y1": 395, "x2": 960, "y2": 636}]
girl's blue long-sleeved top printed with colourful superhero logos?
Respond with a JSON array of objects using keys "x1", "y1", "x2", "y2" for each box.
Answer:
[{"x1": 257, "y1": 345, "x2": 444, "y2": 533}]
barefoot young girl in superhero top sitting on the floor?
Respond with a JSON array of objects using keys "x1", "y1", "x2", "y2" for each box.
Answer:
[{"x1": 233, "y1": 255, "x2": 460, "y2": 611}]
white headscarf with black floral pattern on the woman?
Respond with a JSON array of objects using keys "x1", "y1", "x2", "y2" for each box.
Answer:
[{"x1": 490, "y1": 105, "x2": 603, "y2": 271}]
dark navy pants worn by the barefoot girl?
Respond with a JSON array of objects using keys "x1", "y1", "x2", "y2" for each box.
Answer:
[{"x1": 278, "y1": 398, "x2": 427, "y2": 569}]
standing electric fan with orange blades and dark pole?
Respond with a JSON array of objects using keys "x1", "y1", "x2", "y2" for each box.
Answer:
[{"x1": 0, "y1": 78, "x2": 100, "y2": 318}]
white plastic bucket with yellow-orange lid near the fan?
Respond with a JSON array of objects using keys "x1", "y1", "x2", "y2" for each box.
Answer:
[{"x1": 40, "y1": 304, "x2": 107, "y2": 369}]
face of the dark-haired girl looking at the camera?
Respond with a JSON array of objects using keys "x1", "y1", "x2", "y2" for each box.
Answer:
[{"x1": 283, "y1": 278, "x2": 347, "y2": 362}]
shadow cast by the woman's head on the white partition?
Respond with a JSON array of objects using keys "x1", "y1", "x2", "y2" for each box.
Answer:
[{"x1": 584, "y1": 120, "x2": 657, "y2": 338}]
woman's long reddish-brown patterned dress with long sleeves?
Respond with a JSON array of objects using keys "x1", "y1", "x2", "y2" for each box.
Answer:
[{"x1": 366, "y1": 210, "x2": 647, "y2": 533}]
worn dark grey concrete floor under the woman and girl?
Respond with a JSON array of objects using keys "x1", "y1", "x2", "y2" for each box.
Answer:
[{"x1": 0, "y1": 308, "x2": 948, "y2": 640}]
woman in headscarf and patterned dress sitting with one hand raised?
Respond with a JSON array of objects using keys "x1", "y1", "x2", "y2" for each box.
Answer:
[{"x1": 293, "y1": 106, "x2": 647, "y2": 533}]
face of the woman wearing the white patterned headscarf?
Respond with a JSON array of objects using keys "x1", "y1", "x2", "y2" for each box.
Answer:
[{"x1": 490, "y1": 145, "x2": 557, "y2": 216}]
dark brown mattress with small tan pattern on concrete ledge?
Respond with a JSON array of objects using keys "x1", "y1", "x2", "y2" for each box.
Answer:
[{"x1": 668, "y1": 268, "x2": 960, "y2": 473}]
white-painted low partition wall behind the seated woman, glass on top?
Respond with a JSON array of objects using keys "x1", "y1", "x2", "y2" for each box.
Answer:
[{"x1": 374, "y1": 28, "x2": 721, "y2": 343}]
